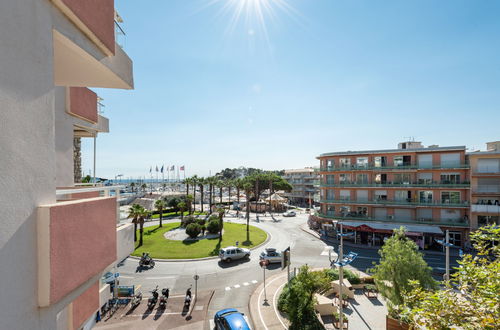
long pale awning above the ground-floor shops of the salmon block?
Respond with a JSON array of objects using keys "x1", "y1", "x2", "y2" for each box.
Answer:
[{"x1": 339, "y1": 221, "x2": 443, "y2": 236}]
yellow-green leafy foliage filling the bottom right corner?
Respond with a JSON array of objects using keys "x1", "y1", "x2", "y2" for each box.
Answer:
[{"x1": 400, "y1": 225, "x2": 500, "y2": 329}]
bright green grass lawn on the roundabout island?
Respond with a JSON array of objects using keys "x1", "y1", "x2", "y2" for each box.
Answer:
[{"x1": 132, "y1": 222, "x2": 267, "y2": 259}]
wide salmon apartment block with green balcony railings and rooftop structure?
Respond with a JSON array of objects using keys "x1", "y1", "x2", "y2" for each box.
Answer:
[{"x1": 318, "y1": 141, "x2": 470, "y2": 248}]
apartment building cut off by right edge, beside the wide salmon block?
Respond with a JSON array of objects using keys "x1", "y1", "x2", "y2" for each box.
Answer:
[{"x1": 467, "y1": 141, "x2": 500, "y2": 230}]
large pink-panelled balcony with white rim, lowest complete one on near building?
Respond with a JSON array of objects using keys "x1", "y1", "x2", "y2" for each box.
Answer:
[{"x1": 37, "y1": 186, "x2": 124, "y2": 307}]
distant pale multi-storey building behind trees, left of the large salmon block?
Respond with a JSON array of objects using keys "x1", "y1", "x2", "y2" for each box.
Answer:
[{"x1": 284, "y1": 167, "x2": 319, "y2": 206}]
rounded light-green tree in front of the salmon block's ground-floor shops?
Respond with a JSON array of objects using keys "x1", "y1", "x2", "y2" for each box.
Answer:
[{"x1": 371, "y1": 227, "x2": 437, "y2": 314}]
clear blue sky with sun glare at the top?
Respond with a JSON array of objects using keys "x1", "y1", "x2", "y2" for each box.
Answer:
[{"x1": 82, "y1": 0, "x2": 500, "y2": 179}]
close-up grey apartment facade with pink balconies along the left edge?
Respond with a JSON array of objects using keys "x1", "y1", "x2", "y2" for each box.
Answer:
[{"x1": 0, "y1": 0, "x2": 134, "y2": 330}]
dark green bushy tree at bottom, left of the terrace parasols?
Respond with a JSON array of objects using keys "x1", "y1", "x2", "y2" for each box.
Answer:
[{"x1": 278, "y1": 265, "x2": 330, "y2": 330}]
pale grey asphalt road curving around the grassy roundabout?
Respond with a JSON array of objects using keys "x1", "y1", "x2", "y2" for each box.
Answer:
[{"x1": 117, "y1": 213, "x2": 456, "y2": 328}]
